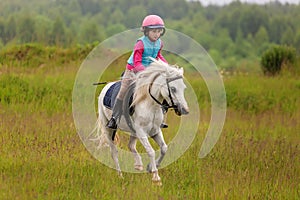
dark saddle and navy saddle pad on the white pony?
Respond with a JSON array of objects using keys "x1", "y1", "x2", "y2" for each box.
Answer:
[{"x1": 103, "y1": 81, "x2": 134, "y2": 115}]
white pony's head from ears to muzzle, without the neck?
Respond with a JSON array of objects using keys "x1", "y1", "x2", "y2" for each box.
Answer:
[{"x1": 161, "y1": 66, "x2": 189, "y2": 116}]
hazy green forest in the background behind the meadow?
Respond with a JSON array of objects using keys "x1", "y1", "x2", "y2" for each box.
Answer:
[{"x1": 0, "y1": 0, "x2": 300, "y2": 68}]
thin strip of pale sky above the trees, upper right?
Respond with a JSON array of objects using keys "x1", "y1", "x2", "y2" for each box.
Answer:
[{"x1": 199, "y1": 0, "x2": 300, "y2": 6}]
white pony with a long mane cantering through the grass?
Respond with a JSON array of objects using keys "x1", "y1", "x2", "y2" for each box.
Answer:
[{"x1": 97, "y1": 60, "x2": 189, "y2": 183}]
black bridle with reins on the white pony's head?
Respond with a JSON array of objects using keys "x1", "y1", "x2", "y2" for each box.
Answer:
[{"x1": 148, "y1": 74, "x2": 183, "y2": 113}]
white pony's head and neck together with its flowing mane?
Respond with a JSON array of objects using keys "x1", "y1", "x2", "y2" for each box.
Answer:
[{"x1": 133, "y1": 59, "x2": 189, "y2": 116}]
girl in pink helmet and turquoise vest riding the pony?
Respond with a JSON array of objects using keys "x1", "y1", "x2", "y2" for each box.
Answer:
[{"x1": 107, "y1": 15, "x2": 168, "y2": 129}]
